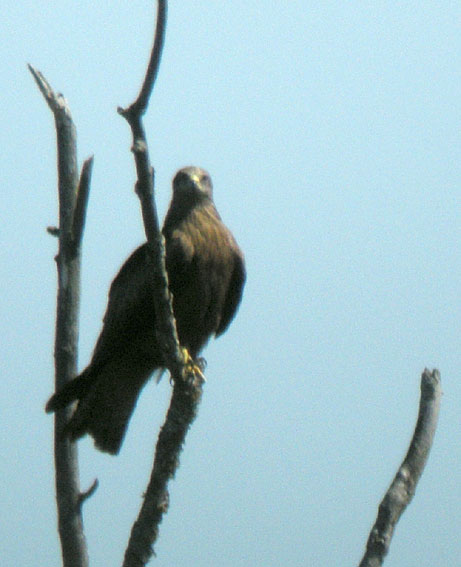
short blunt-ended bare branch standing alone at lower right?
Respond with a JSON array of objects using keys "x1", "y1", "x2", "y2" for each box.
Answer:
[{"x1": 359, "y1": 368, "x2": 442, "y2": 567}]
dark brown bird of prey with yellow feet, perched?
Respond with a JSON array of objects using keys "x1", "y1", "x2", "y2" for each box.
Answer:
[{"x1": 46, "y1": 167, "x2": 246, "y2": 455}]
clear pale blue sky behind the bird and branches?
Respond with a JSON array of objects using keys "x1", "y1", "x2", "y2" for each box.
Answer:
[{"x1": 0, "y1": 0, "x2": 461, "y2": 567}]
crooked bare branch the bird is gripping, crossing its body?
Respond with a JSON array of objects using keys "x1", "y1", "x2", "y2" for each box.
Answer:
[{"x1": 118, "y1": 0, "x2": 204, "y2": 567}]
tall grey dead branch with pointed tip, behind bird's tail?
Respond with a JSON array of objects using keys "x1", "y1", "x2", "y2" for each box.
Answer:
[{"x1": 29, "y1": 65, "x2": 91, "y2": 567}]
